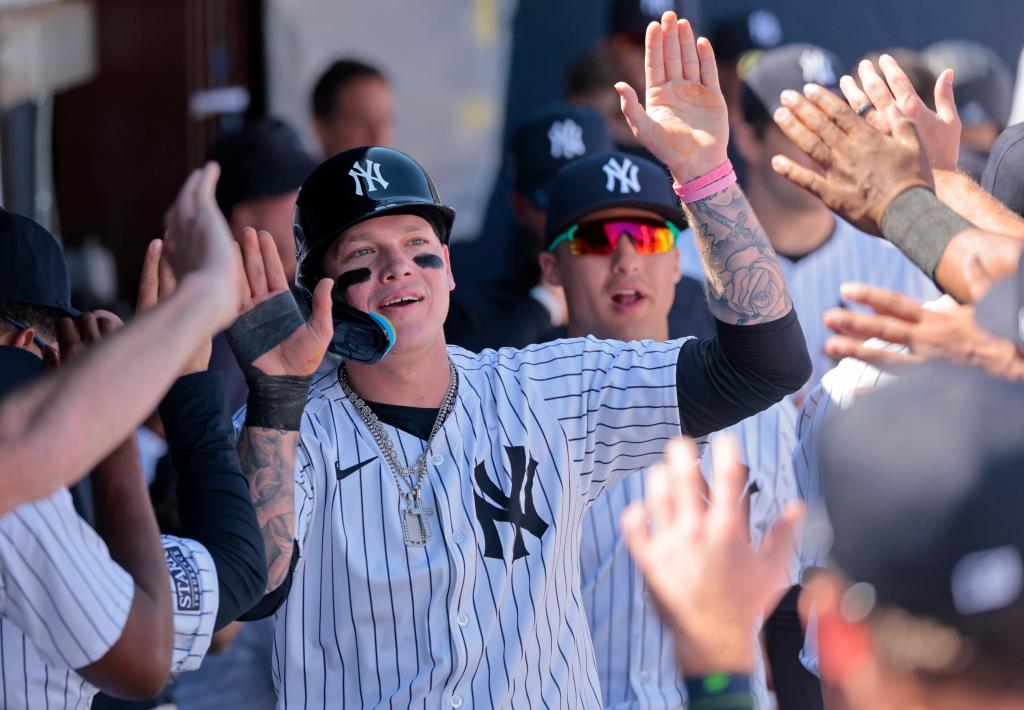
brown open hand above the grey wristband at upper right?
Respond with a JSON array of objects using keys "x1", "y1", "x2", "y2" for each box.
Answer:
[{"x1": 772, "y1": 84, "x2": 935, "y2": 235}]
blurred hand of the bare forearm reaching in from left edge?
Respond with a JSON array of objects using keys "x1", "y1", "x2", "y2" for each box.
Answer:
[{"x1": 163, "y1": 163, "x2": 239, "y2": 330}]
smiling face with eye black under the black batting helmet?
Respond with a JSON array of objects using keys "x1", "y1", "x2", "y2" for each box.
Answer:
[{"x1": 324, "y1": 214, "x2": 455, "y2": 406}]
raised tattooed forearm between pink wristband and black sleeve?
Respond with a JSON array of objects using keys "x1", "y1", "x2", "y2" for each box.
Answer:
[{"x1": 686, "y1": 184, "x2": 793, "y2": 325}]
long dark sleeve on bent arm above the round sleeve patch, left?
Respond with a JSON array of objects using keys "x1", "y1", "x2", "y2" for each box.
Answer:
[{"x1": 160, "y1": 371, "x2": 266, "y2": 629}]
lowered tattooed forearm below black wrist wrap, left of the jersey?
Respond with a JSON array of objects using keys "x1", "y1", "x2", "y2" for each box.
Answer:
[{"x1": 239, "y1": 426, "x2": 299, "y2": 592}]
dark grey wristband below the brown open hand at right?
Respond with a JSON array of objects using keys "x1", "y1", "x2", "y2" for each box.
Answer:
[{"x1": 882, "y1": 187, "x2": 974, "y2": 281}]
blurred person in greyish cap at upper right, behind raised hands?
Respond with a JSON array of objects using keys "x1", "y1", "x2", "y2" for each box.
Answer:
[{"x1": 922, "y1": 40, "x2": 1014, "y2": 180}]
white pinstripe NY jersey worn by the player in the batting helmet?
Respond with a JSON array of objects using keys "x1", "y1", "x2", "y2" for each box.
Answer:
[{"x1": 256, "y1": 338, "x2": 683, "y2": 708}]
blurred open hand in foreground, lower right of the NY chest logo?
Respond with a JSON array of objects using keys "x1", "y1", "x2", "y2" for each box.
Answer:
[{"x1": 622, "y1": 436, "x2": 803, "y2": 675}]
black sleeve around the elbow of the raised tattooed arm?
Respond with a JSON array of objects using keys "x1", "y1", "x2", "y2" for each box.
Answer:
[{"x1": 676, "y1": 310, "x2": 811, "y2": 436}]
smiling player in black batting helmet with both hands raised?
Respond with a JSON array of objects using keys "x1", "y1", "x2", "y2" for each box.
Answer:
[{"x1": 236, "y1": 12, "x2": 810, "y2": 708}]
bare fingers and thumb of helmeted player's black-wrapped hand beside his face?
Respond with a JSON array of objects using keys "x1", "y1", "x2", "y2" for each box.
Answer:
[{"x1": 240, "y1": 227, "x2": 334, "y2": 376}]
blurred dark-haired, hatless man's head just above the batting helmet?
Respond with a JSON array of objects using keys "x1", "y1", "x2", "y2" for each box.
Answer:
[{"x1": 312, "y1": 58, "x2": 394, "y2": 158}]
